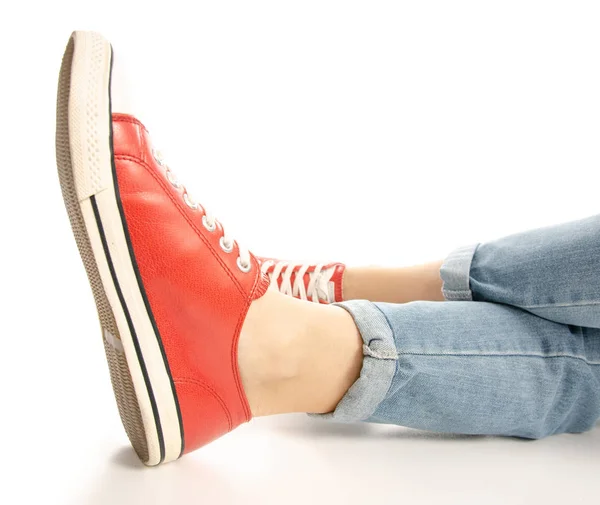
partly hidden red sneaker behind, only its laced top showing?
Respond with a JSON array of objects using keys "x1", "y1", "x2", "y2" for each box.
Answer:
[{"x1": 260, "y1": 258, "x2": 346, "y2": 303}]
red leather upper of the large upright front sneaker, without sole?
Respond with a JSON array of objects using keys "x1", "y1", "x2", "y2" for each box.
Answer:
[{"x1": 113, "y1": 114, "x2": 268, "y2": 452}]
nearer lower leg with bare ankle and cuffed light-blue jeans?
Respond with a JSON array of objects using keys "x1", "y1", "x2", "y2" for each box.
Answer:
[{"x1": 240, "y1": 292, "x2": 600, "y2": 438}]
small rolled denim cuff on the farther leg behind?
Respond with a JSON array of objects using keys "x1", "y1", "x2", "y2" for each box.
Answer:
[{"x1": 440, "y1": 244, "x2": 479, "y2": 301}]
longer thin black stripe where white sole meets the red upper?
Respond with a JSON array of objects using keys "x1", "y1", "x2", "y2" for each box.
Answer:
[{"x1": 108, "y1": 46, "x2": 185, "y2": 456}]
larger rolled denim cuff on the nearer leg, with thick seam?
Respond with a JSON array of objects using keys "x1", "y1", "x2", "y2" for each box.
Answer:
[{"x1": 309, "y1": 300, "x2": 398, "y2": 422}]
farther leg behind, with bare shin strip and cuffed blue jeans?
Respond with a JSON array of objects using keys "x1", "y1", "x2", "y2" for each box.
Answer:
[{"x1": 343, "y1": 216, "x2": 600, "y2": 328}]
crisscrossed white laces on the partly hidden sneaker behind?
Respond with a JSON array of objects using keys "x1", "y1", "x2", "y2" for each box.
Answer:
[{"x1": 260, "y1": 260, "x2": 335, "y2": 303}]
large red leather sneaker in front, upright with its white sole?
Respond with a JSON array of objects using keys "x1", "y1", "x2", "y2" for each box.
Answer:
[{"x1": 56, "y1": 32, "x2": 268, "y2": 465}]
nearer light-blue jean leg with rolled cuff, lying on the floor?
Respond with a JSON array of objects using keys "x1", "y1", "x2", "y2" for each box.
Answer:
[{"x1": 314, "y1": 300, "x2": 600, "y2": 439}]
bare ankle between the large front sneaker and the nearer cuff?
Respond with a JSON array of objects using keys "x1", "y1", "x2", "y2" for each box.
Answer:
[{"x1": 239, "y1": 291, "x2": 362, "y2": 416}]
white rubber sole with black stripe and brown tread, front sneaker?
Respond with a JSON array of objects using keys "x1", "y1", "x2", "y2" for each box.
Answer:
[{"x1": 56, "y1": 32, "x2": 184, "y2": 466}]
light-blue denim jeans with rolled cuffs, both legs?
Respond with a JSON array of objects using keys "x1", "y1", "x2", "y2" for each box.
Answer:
[{"x1": 321, "y1": 216, "x2": 600, "y2": 439}]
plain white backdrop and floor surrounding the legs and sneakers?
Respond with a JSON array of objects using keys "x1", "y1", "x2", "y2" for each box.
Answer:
[{"x1": 0, "y1": 0, "x2": 600, "y2": 505}]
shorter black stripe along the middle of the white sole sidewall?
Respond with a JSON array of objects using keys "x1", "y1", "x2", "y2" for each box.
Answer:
[{"x1": 90, "y1": 195, "x2": 165, "y2": 463}]
